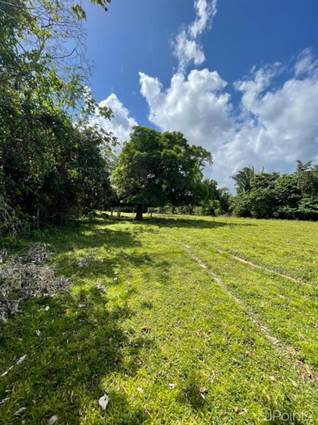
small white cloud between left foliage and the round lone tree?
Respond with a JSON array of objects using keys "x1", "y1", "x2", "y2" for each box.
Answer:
[{"x1": 91, "y1": 93, "x2": 137, "y2": 144}]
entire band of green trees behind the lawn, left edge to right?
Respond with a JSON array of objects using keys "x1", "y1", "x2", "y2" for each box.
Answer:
[{"x1": 0, "y1": 0, "x2": 318, "y2": 234}]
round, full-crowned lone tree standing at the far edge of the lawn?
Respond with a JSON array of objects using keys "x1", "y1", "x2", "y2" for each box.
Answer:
[{"x1": 113, "y1": 127, "x2": 211, "y2": 220}]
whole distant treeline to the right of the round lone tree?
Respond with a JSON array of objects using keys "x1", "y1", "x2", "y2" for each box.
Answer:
[{"x1": 123, "y1": 161, "x2": 318, "y2": 220}]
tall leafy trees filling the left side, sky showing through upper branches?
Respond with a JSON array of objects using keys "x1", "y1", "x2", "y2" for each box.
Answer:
[{"x1": 0, "y1": 0, "x2": 113, "y2": 233}]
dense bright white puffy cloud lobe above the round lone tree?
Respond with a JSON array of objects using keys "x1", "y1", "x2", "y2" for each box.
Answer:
[{"x1": 139, "y1": 69, "x2": 232, "y2": 146}]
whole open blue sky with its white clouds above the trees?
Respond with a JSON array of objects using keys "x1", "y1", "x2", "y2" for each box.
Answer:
[{"x1": 84, "y1": 0, "x2": 318, "y2": 185}]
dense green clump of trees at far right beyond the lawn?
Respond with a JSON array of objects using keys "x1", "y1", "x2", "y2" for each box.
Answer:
[{"x1": 230, "y1": 161, "x2": 318, "y2": 220}]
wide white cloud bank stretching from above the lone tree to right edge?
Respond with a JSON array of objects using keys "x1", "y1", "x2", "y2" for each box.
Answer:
[{"x1": 140, "y1": 50, "x2": 318, "y2": 187}]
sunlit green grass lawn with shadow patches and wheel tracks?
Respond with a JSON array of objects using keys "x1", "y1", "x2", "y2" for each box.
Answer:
[{"x1": 0, "y1": 216, "x2": 318, "y2": 425}]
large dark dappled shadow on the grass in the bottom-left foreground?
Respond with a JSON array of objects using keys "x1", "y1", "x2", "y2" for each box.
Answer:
[{"x1": 0, "y1": 288, "x2": 153, "y2": 425}]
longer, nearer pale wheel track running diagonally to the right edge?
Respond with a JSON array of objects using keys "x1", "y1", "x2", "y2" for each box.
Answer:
[{"x1": 185, "y1": 245, "x2": 318, "y2": 384}]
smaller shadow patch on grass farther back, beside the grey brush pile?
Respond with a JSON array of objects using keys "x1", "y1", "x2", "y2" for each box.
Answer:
[{"x1": 29, "y1": 220, "x2": 147, "y2": 283}]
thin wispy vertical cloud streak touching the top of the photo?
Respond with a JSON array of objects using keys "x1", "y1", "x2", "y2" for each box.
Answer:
[{"x1": 174, "y1": 0, "x2": 217, "y2": 71}]
